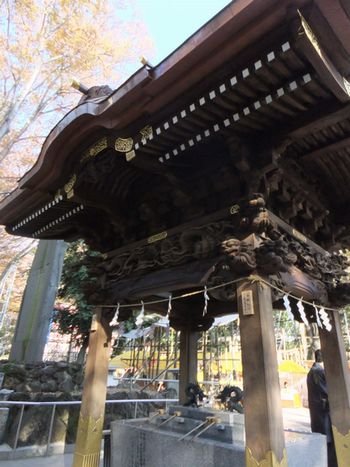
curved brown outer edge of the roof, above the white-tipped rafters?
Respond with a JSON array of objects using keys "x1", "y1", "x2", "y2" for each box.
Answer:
[{"x1": 0, "y1": 0, "x2": 344, "y2": 224}]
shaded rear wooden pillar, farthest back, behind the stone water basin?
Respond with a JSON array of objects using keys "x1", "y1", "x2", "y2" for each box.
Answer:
[{"x1": 179, "y1": 329, "x2": 198, "y2": 404}]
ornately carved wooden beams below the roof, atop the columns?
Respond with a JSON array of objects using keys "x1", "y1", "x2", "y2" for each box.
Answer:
[{"x1": 91, "y1": 194, "x2": 349, "y2": 311}]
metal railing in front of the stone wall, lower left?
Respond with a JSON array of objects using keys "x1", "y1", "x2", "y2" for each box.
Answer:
[{"x1": 0, "y1": 398, "x2": 178, "y2": 460}]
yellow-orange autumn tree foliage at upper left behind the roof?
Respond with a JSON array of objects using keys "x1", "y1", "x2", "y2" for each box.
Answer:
[{"x1": 0, "y1": 0, "x2": 153, "y2": 318}]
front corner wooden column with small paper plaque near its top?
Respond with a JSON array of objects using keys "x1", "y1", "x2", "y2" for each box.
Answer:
[{"x1": 237, "y1": 282, "x2": 287, "y2": 467}]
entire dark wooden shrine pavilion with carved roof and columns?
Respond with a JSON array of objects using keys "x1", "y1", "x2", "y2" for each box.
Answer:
[{"x1": 0, "y1": 0, "x2": 350, "y2": 467}]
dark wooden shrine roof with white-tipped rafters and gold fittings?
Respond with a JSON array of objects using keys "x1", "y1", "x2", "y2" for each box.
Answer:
[{"x1": 0, "y1": 0, "x2": 350, "y2": 251}]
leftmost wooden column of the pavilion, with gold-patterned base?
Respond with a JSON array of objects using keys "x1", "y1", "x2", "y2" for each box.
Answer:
[{"x1": 73, "y1": 309, "x2": 111, "y2": 467}]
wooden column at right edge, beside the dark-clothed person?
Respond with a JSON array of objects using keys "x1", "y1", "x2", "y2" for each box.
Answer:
[{"x1": 320, "y1": 311, "x2": 350, "y2": 467}]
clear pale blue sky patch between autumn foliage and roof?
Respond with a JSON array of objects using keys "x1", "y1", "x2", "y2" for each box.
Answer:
[{"x1": 135, "y1": 0, "x2": 230, "y2": 65}]
